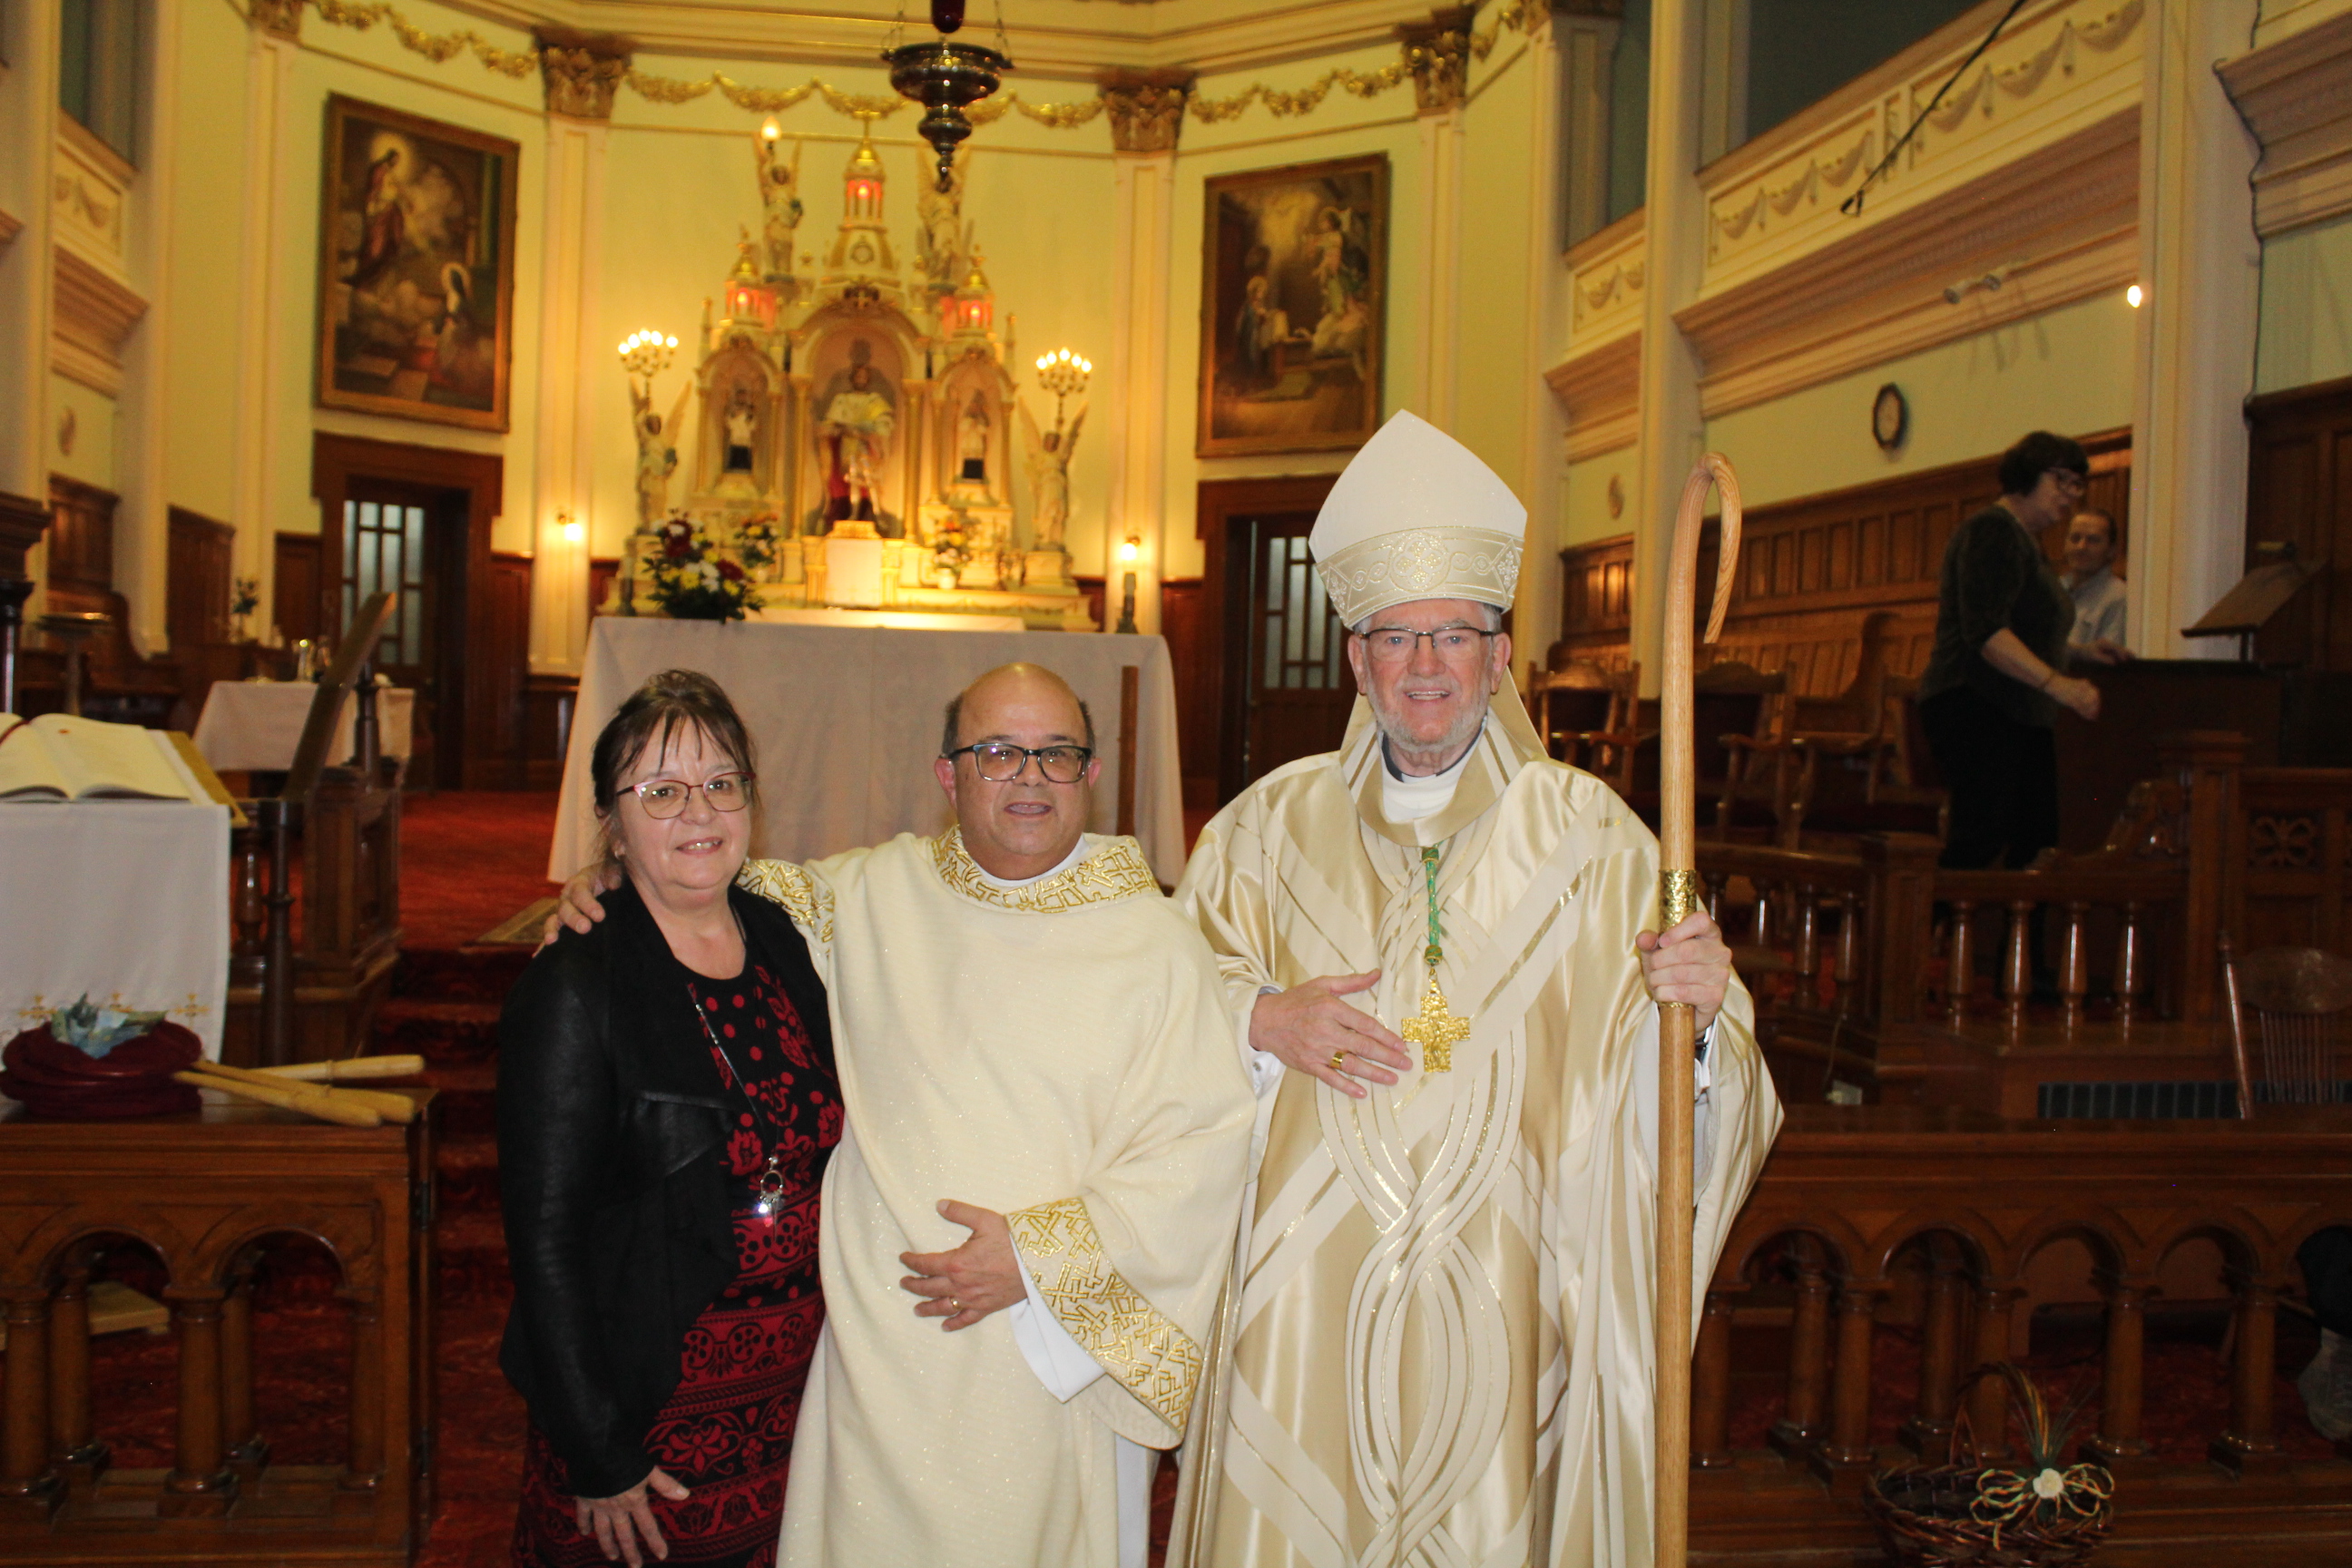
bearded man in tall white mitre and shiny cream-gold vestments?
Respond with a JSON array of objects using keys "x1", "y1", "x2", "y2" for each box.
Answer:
[{"x1": 1169, "y1": 414, "x2": 1780, "y2": 1568}]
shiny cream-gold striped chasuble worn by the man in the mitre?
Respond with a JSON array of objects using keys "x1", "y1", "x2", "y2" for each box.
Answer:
[{"x1": 1169, "y1": 693, "x2": 1780, "y2": 1568}]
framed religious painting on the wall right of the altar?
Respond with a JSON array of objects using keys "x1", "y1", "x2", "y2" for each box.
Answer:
[{"x1": 1195, "y1": 152, "x2": 1387, "y2": 458}]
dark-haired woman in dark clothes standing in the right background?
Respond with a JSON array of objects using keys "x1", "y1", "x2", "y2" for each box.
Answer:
[{"x1": 1919, "y1": 430, "x2": 2098, "y2": 870}]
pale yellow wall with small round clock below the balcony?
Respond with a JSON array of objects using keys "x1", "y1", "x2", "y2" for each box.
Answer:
[{"x1": 1702, "y1": 283, "x2": 2133, "y2": 503}]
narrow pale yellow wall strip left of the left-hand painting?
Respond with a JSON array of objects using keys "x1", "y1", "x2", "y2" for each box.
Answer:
[{"x1": 162, "y1": 5, "x2": 247, "y2": 522}]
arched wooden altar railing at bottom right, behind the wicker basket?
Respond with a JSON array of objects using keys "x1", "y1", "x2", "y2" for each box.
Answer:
[{"x1": 1691, "y1": 1105, "x2": 2352, "y2": 1561}]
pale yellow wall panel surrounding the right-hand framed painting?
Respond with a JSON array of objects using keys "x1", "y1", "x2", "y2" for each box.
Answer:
[{"x1": 1157, "y1": 49, "x2": 1427, "y2": 578}]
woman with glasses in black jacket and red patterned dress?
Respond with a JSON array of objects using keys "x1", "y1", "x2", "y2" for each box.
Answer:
[{"x1": 499, "y1": 670, "x2": 842, "y2": 1568}]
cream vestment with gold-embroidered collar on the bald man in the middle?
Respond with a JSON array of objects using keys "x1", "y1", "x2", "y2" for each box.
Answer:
[{"x1": 740, "y1": 828, "x2": 1251, "y2": 1568}]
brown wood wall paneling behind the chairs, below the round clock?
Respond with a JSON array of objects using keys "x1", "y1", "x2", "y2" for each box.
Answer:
[{"x1": 1550, "y1": 430, "x2": 2131, "y2": 696}]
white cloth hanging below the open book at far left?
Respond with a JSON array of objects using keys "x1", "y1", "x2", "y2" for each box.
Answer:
[{"x1": 0, "y1": 799, "x2": 228, "y2": 1058}]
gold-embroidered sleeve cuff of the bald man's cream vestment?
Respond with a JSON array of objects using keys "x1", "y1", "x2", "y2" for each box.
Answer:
[{"x1": 1004, "y1": 1199, "x2": 1202, "y2": 1432}]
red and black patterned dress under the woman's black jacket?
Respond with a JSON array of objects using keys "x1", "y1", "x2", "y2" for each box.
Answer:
[{"x1": 515, "y1": 955, "x2": 842, "y2": 1568}]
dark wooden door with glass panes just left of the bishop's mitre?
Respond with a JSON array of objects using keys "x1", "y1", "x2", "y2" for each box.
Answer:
[{"x1": 1225, "y1": 513, "x2": 1355, "y2": 788}]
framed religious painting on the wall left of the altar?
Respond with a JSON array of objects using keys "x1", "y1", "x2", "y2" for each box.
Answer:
[{"x1": 318, "y1": 94, "x2": 522, "y2": 430}]
